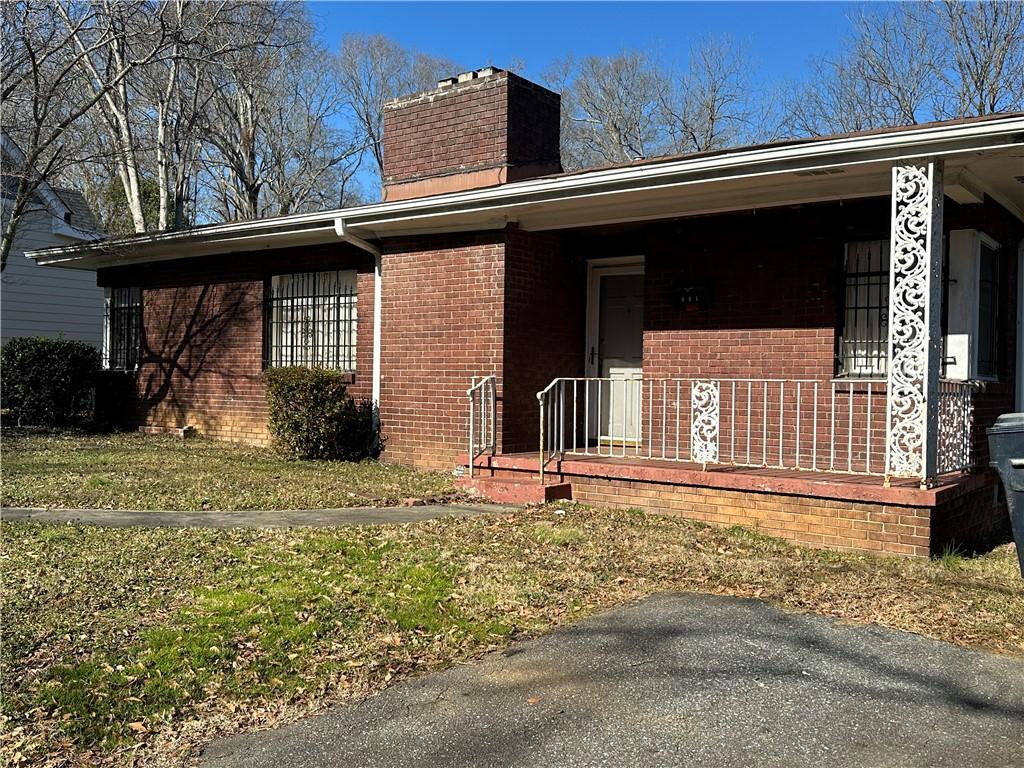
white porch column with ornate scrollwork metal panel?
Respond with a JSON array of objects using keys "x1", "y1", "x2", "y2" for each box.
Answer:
[{"x1": 886, "y1": 159, "x2": 943, "y2": 485}]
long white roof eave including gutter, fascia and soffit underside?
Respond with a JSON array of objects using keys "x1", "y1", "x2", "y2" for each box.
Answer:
[{"x1": 27, "y1": 113, "x2": 1024, "y2": 269}]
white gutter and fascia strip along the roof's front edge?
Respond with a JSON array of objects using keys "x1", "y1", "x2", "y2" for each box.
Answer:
[{"x1": 29, "y1": 116, "x2": 1024, "y2": 268}]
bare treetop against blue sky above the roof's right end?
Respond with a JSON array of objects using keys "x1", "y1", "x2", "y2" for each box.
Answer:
[{"x1": 787, "y1": 0, "x2": 1024, "y2": 135}]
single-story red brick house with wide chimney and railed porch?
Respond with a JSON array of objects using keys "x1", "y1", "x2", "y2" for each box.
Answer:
[{"x1": 32, "y1": 68, "x2": 1024, "y2": 555}]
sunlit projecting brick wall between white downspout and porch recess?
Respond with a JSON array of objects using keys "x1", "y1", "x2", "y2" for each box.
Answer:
[{"x1": 381, "y1": 230, "x2": 505, "y2": 469}]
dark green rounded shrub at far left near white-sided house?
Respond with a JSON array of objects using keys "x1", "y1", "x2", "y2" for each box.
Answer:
[{"x1": 0, "y1": 336, "x2": 99, "y2": 427}]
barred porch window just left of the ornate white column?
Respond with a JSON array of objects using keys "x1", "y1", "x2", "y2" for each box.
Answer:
[{"x1": 839, "y1": 240, "x2": 889, "y2": 378}]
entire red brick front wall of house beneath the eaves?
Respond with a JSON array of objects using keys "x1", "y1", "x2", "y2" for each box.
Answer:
[{"x1": 99, "y1": 193, "x2": 1020, "y2": 481}]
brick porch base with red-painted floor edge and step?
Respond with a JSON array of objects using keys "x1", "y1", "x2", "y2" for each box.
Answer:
[{"x1": 460, "y1": 455, "x2": 1007, "y2": 557}]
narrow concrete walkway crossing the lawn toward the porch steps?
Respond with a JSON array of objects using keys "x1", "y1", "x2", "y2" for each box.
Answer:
[{"x1": 0, "y1": 504, "x2": 513, "y2": 528}]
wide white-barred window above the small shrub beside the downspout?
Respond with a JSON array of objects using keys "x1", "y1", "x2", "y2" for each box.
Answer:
[{"x1": 264, "y1": 270, "x2": 356, "y2": 371}]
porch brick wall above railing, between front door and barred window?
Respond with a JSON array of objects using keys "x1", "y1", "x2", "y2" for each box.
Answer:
[{"x1": 644, "y1": 206, "x2": 851, "y2": 379}]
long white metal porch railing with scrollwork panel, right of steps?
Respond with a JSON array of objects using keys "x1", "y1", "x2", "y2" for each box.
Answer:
[{"x1": 537, "y1": 377, "x2": 972, "y2": 482}]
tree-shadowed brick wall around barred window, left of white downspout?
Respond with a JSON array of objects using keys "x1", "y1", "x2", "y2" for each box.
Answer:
[{"x1": 98, "y1": 244, "x2": 373, "y2": 443}]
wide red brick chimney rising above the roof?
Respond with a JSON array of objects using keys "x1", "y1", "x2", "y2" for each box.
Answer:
[{"x1": 384, "y1": 67, "x2": 562, "y2": 200}]
